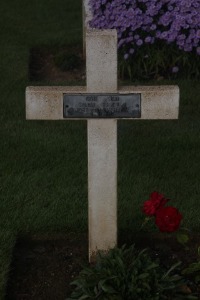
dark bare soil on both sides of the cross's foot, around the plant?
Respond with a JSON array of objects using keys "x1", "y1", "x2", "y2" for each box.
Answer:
[{"x1": 6, "y1": 234, "x2": 200, "y2": 300}]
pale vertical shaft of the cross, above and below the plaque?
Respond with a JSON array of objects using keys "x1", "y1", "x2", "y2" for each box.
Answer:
[{"x1": 86, "y1": 30, "x2": 117, "y2": 261}]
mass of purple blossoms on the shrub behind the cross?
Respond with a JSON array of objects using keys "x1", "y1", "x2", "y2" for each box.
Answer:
[{"x1": 89, "y1": 0, "x2": 200, "y2": 59}]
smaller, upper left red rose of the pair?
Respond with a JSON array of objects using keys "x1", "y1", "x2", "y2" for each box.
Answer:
[{"x1": 142, "y1": 192, "x2": 169, "y2": 216}]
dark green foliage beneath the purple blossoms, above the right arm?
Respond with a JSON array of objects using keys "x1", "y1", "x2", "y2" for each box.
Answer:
[{"x1": 119, "y1": 41, "x2": 200, "y2": 81}]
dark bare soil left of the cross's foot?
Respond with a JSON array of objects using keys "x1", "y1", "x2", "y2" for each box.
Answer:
[{"x1": 6, "y1": 234, "x2": 87, "y2": 300}]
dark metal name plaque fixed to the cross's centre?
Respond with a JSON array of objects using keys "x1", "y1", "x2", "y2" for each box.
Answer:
[{"x1": 63, "y1": 94, "x2": 141, "y2": 118}]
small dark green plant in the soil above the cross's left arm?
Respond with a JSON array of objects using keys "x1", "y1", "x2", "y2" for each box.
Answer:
[{"x1": 54, "y1": 52, "x2": 81, "y2": 72}]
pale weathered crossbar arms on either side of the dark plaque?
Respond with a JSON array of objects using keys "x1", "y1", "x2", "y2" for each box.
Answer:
[{"x1": 26, "y1": 84, "x2": 179, "y2": 120}]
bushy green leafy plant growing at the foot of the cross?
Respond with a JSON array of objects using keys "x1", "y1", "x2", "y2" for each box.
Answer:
[{"x1": 67, "y1": 246, "x2": 197, "y2": 300}]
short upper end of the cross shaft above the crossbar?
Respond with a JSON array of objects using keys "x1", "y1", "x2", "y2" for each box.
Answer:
[{"x1": 86, "y1": 30, "x2": 117, "y2": 93}]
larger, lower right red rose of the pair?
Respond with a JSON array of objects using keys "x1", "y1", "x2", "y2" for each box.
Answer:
[{"x1": 155, "y1": 206, "x2": 182, "y2": 232}]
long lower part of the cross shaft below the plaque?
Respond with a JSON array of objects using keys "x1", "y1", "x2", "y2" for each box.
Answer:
[{"x1": 88, "y1": 119, "x2": 117, "y2": 261}]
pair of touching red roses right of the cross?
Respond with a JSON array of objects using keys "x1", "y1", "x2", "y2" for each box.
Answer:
[{"x1": 142, "y1": 192, "x2": 182, "y2": 232}]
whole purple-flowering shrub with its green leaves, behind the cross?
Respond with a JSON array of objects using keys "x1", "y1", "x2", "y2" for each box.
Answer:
[{"x1": 90, "y1": 0, "x2": 200, "y2": 78}]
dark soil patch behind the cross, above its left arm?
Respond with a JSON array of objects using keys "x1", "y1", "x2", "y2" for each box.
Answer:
[{"x1": 29, "y1": 46, "x2": 86, "y2": 83}]
